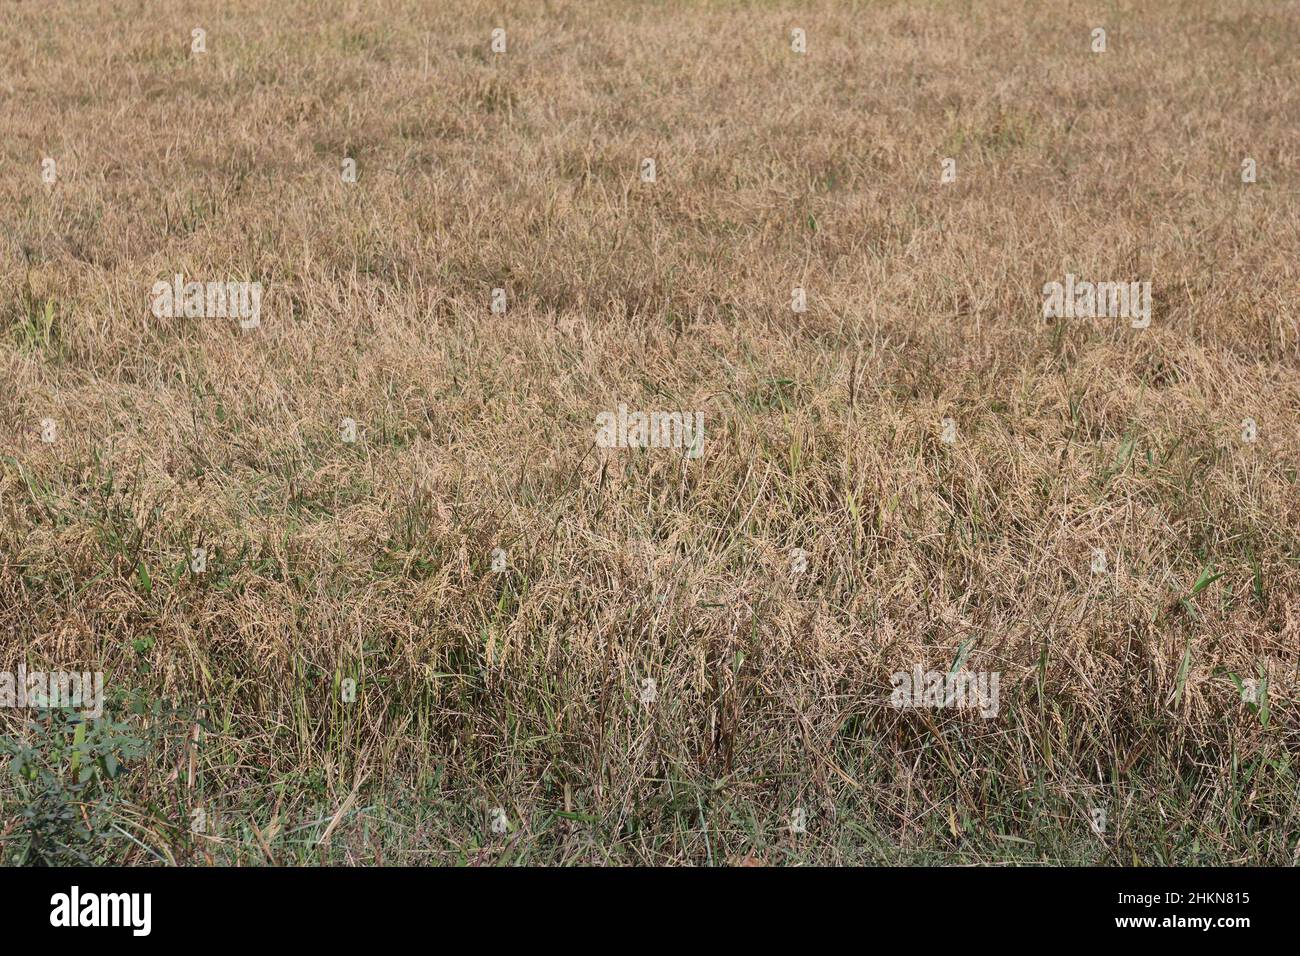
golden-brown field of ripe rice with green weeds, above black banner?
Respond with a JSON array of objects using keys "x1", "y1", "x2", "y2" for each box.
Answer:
[{"x1": 0, "y1": 0, "x2": 1300, "y2": 865}]
